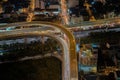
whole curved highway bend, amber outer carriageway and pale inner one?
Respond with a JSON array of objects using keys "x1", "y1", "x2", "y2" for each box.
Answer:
[{"x1": 0, "y1": 21, "x2": 78, "y2": 80}]
